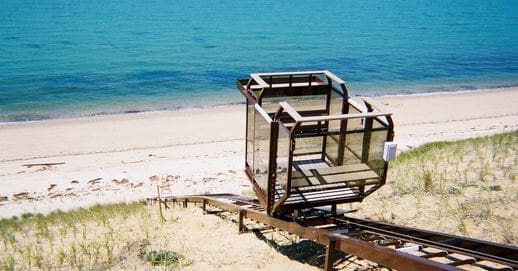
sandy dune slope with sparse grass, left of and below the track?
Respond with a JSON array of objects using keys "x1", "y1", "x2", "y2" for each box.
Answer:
[{"x1": 0, "y1": 203, "x2": 332, "y2": 270}]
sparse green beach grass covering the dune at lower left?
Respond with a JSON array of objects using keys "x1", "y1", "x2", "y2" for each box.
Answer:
[{"x1": 0, "y1": 202, "x2": 193, "y2": 270}]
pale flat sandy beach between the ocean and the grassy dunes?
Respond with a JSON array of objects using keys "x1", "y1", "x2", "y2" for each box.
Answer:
[{"x1": 0, "y1": 87, "x2": 518, "y2": 217}]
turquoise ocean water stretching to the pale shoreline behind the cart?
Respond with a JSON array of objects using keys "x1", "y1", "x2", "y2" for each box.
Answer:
[{"x1": 0, "y1": 0, "x2": 518, "y2": 122}]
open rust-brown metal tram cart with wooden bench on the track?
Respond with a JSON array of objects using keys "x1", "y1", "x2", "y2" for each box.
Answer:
[{"x1": 237, "y1": 71, "x2": 395, "y2": 214}]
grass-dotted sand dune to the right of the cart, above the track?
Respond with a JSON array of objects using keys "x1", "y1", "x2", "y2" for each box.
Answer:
[{"x1": 358, "y1": 131, "x2": 518, "y2": 245}]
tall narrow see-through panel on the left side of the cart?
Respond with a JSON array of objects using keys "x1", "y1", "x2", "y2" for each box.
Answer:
[{"x1": 254, "y1": 107, "x2": 271, "y2": 197}]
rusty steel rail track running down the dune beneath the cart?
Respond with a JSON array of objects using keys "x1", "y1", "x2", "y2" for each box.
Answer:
[{"x1": 148, "y1": 194, "x2": 518, "y2": 271}]
